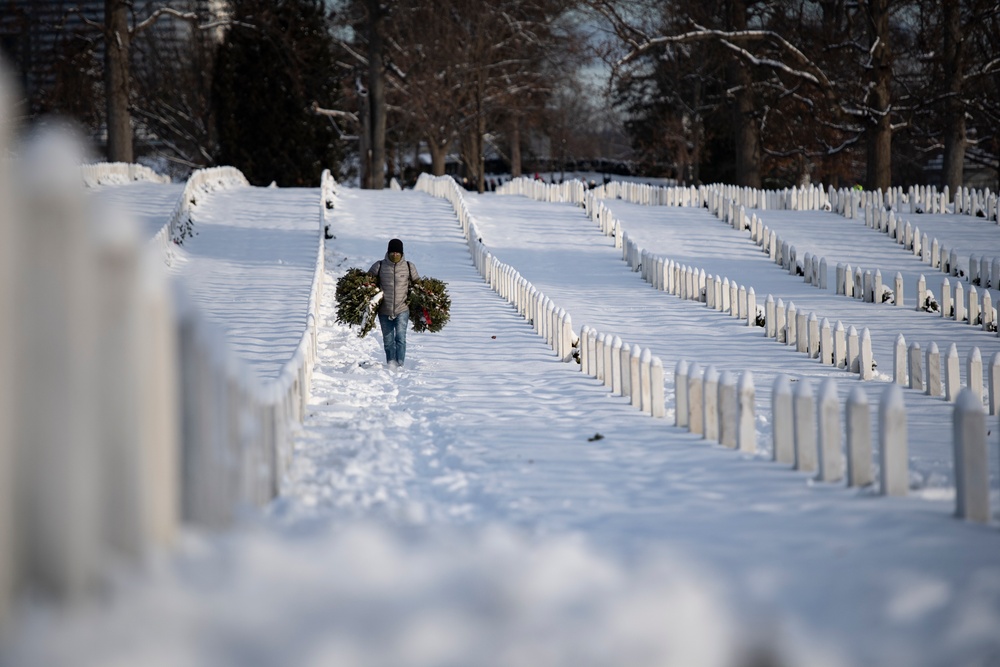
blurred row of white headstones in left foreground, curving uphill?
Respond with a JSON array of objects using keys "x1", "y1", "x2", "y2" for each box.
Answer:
[{"x1": 0, "y1": 132, "x2": 324, "y2": 617}]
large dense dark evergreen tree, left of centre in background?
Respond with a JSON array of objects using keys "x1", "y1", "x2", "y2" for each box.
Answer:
[{"x1": 213, "y1": 0, "x2": 340, "y2": 187}]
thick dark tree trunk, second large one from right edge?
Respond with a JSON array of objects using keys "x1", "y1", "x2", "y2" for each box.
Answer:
[{"x1": 865, "y1": 0, "x2": 892, "y2": 191}]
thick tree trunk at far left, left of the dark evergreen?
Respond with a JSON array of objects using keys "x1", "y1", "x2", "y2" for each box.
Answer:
[{"x1": 104, "y1": 0, "x2": 135, "y2": 162}]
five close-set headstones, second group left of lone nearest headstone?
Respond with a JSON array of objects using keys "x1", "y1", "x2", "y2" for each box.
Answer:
[{"x1": 674, "y1": 359, "x2": 757, "y2": 454}]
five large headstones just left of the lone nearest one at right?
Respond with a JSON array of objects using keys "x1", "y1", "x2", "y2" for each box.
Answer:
[{"x1": 771, "y1": 374, "x2": 909, "y2": 496}]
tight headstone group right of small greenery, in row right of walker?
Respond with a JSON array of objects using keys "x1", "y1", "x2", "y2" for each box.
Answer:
[{"x1": 580, "y1": 326, "x2": 665, "y2": 417}]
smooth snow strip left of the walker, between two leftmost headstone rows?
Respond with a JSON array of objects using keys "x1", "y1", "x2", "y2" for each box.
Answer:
[{"x1": 178, "y1": 187, "x2": 320, "y2": 378}]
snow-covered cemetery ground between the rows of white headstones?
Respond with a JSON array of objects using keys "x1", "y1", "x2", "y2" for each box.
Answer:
[{"x1": 6, "y1": 183, "x2": 1000, "y2": 666}]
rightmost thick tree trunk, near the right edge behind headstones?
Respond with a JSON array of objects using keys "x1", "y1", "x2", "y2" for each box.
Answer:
[{"x1": 941, "y1": 2, "x2": 966, "y2": 193}]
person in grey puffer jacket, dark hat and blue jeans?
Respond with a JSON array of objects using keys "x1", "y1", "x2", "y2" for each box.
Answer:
[{"x1": 368, "y1": 239, "x2": 420, "y2": 368}]
